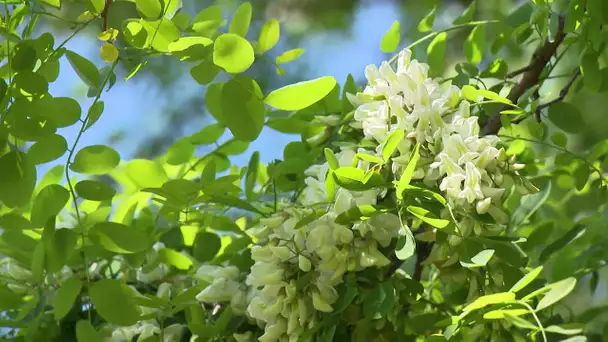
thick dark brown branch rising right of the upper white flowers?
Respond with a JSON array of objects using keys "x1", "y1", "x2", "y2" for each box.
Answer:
[{"x1": 482, "y1": 16, "x2": 566, "y2": 135}]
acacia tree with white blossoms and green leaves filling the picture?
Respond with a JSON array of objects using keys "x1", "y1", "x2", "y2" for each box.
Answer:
[{"x1": 0, "y1": 0, "x2": 608, "y2": 341}]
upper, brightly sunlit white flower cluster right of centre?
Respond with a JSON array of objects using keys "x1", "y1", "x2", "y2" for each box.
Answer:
[{"x1": 347, "y1": 50, "x2": 512, "y2": 223}]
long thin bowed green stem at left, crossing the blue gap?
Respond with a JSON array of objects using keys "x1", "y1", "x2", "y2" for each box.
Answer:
[{"x1": 65, "y1": 60, "x2": 118, "y2": 321}]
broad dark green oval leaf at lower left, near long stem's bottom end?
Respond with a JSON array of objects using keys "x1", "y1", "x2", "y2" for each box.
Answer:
[{"x1": 89, "y1": 279, "x2": 141, "y2": 326}]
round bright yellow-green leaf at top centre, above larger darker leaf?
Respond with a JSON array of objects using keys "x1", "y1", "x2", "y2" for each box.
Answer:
[{"x1": 213, "y1": 33, "x2": 255, "y2": 74}]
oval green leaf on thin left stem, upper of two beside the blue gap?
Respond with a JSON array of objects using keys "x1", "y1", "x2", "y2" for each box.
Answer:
[{"x1": 70, "y1": 145, "x2": 120, "y2": 175}]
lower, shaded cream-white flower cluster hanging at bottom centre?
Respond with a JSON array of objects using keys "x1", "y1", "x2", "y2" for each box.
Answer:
[{"x1": 240, "y1": 204, "x2": 400, "y2": 341}]
